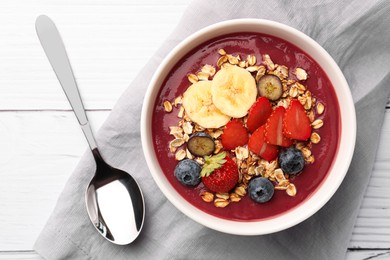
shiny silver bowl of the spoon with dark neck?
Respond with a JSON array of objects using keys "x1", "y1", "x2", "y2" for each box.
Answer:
[{"x1": 85, "y1": 148, "x2": 144, "y2": 245}]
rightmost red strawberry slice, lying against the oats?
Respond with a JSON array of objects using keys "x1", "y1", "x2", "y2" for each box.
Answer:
[{"x1": 283, "y1": 100, "x2": 312, "y2": 141}]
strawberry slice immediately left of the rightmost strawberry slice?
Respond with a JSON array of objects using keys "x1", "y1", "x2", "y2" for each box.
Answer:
[{"x1": 264, "y1": 107, "x2": 293, "y2": 147}]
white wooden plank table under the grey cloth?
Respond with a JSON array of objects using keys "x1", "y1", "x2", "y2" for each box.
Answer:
[{"x1": 0, "y1": 0, "x2": 390, "y2": 259}]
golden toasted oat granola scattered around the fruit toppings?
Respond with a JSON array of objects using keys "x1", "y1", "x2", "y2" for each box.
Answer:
[{"x1": 163, "y1": 49, "x2": 325, "y2": 207}]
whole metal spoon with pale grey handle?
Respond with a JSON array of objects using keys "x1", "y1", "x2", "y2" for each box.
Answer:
[{"x1": 35, "y1": 15, "x2": 145, "y2": 245}]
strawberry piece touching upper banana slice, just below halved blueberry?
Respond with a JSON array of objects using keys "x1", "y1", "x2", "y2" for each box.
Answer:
[{"x1": 246, "y1": 97, "x2": 272, "y2": 133}]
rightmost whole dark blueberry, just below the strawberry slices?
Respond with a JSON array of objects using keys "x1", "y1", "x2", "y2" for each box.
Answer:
[{"x1": 279, "y1": 147, "x2": 305, "y2": 175}]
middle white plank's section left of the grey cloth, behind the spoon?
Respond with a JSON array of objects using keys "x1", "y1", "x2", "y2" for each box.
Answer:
[{"x1": 0, "y1": 111, "x2": 109, "y2": 251}]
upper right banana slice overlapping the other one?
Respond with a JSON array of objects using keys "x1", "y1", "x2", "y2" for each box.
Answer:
[{"x1": 211, "y1": 66, "x2": 257, "y2": 118}]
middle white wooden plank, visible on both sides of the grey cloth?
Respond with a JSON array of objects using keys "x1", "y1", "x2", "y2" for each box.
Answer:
[{"x1": 0, "y1": 110, "x2": 390, "y2": 251}]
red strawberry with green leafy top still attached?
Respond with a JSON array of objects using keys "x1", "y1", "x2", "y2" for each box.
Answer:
[{"x1": 200, "y1": 152, "x2": 239, "y2": 192}]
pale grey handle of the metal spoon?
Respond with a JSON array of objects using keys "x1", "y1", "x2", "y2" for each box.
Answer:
[{"x1": 35, "y1": 15, "x2": 97, "y2": 150}]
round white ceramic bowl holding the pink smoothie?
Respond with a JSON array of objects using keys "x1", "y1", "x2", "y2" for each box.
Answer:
[{"x1": 141, "y1": 19, "x2": 356, "y2": 235}]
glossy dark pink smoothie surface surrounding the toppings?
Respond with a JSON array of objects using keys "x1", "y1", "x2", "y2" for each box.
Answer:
[{"x1": 152, "y1": 32, "x2": 341, "y2": 221}]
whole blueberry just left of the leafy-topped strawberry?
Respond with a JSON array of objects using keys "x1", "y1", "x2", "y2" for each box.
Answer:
[{"x1": 174, "y1": 159, "x2": 202, "y2": 186}]
